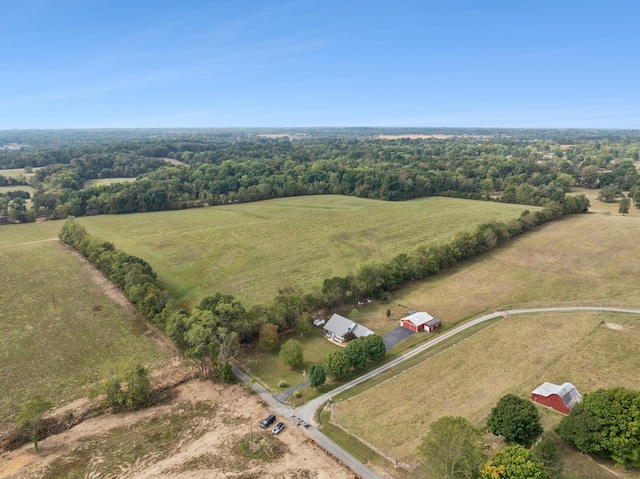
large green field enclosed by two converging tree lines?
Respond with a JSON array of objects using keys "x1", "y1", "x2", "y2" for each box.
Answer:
[{"x1": 72, "y1": 196, "x2": 532, "y2": 306}]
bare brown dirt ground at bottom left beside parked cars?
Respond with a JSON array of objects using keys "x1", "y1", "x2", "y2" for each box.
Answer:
[{"x1": 0, "y1": 380, "x2": 354, "y2": 479}]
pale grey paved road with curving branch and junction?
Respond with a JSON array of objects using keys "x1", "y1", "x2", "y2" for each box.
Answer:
[{"x1": 234, "y1": 306, "x2": 640, "y2": 479}]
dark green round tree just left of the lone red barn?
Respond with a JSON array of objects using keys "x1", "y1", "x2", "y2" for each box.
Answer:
[{"x1": 487, "y1": 394, "x2": 542, "y2": 446}]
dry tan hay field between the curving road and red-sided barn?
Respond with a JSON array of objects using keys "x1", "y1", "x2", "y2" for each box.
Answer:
[{"x1": 332, "y1": 313, "x2": 640, "y2": 463}]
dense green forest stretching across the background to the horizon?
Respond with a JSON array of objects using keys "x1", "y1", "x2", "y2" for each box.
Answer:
[{"x1": 0, "y1": 128, "x2": 640, "y2": 222}]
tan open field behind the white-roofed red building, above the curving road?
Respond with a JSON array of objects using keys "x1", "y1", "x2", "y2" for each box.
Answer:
[{"x1": 358, "y1": 207, "x2": 640, "y2": 329}]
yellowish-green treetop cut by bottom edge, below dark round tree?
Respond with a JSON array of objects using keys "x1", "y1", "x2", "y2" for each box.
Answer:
[{"x1": 480, "y1": 444, "x2": 551, "y2": 479}]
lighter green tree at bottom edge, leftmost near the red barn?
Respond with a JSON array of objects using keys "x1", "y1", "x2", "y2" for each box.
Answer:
[{"x1": 418, "y1": 416, "x2": 486, "y2": 479}]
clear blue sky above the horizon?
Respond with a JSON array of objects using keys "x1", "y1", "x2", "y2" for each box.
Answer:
[{"x1": 0, "y1": 0, "x2": 640, "y2": 129}]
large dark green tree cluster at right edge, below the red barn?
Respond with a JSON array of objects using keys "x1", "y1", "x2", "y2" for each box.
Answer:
[{"x1": 557, "y1": 388, "x2": 640, "y2": 467}]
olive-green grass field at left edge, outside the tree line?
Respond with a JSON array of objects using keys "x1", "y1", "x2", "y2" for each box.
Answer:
[{"x1": 0, "y1": 242, "x2": 169, "y2": 423}]
